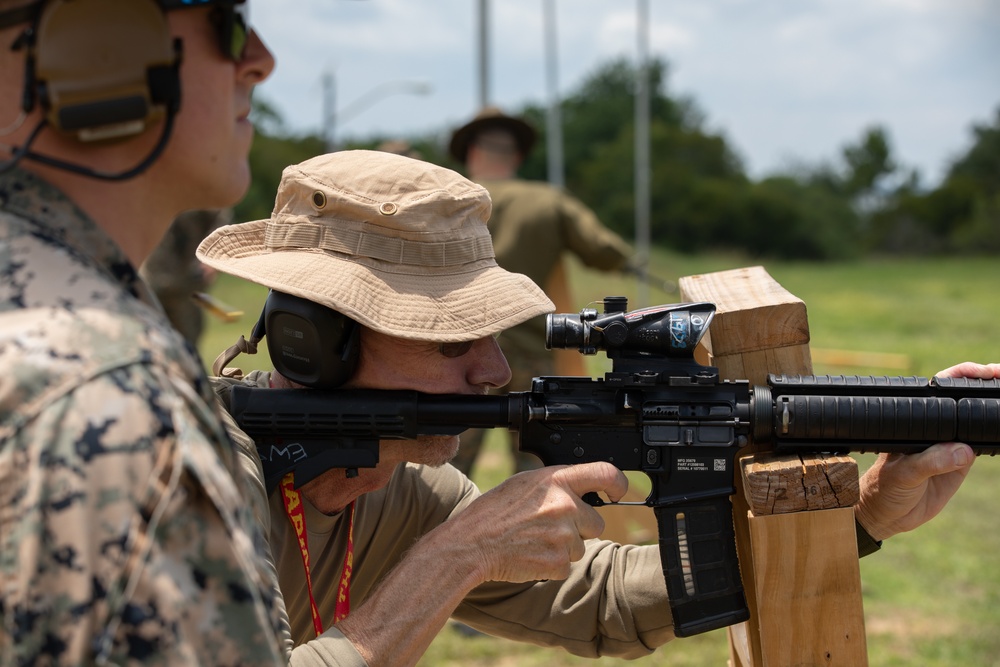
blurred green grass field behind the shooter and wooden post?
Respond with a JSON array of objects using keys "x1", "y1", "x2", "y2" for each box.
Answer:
[{"x1": 201, "y1": 252, "x2": 1000, "y2": 667}]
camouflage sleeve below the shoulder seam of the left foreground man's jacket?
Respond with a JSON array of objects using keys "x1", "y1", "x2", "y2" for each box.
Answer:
[{"x1": 0, "y1": 365, "x2": 285, "y2": 665}]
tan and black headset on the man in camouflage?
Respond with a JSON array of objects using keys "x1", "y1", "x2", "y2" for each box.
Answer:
[{"x1": 0, "y1": 0, "x2": 181, "y2": 180}]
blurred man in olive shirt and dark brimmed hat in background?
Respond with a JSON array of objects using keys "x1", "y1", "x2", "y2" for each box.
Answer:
[{"x1": 448, "y1": 107, "x2": 633, "y2": 475}]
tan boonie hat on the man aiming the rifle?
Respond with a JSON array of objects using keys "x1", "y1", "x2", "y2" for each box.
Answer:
[{"x1": 197, "y1": 150, "x2": 554, "y2": 342}]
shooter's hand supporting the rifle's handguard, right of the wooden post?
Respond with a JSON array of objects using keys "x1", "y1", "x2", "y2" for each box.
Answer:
[{"x1": 855, "y1": 362, "x2": 1000, "y2": 540}]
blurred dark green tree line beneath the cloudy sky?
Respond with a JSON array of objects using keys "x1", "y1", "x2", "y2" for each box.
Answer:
[{"x1": 235, "y1": 59, "x2": 1000, "y2": 260}]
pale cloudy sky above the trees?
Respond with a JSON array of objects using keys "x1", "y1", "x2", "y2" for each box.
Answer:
[{"x1": 251, "y1": 0, "x2": 1000, "y2": 185}]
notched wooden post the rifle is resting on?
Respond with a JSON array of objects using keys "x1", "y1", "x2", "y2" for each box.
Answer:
[{"x1": 680, "y1": 266, "x2": 868, "y2": 667}]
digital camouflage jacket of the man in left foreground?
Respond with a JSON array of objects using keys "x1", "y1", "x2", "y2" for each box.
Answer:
[{"x1": 0, "y1": 170, "x2": 286, "y2": 666}]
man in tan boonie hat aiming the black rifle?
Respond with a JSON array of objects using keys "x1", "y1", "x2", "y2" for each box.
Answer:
[{"x1": 198, "y1": 151, "x2": 984, "y2": 665}]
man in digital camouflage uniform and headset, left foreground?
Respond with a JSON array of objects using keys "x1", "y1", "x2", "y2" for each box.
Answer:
[{"x1": 0, "y1": 0, "x2": 287, "y2": 665}]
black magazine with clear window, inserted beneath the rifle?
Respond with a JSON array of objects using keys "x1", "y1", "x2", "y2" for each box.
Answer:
[{"x1": 653, "y1": 497, "x2": 750, "y2": 637}]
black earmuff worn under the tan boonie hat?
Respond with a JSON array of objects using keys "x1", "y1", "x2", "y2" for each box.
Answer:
[{"x1": 253, "y1": 290, "x2": 361, "y2": 389}]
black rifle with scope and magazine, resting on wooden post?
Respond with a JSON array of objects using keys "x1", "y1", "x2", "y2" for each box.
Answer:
[{"x1": 231, "y1": 297, "x2": 1000, "y2": 637}]
